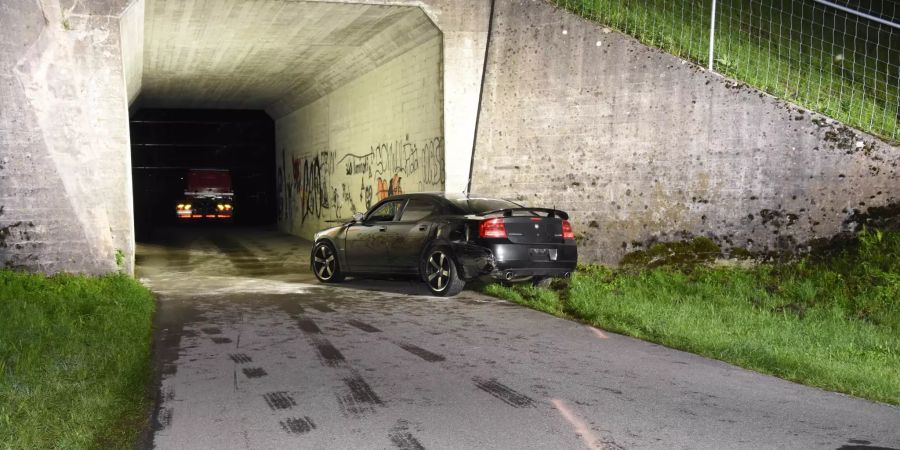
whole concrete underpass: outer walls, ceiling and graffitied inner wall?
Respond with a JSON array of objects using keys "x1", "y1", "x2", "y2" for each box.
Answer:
[{"x1": 0, "y1": 0, "x2": 900, "y2": 273}]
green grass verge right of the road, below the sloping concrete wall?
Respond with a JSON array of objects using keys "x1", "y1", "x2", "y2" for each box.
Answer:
[{"x1": 483, "y1": 231, "x2": 900, "y2": 406}]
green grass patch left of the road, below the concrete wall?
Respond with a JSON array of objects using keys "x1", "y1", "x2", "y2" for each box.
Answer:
[{"x1": 0, "y1": 271, "x2": 154, "y2": 449}]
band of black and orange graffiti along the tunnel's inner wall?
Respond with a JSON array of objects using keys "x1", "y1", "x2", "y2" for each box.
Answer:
[{"x1": 276, "y1": 136, "x2": 445, "y2": 225}]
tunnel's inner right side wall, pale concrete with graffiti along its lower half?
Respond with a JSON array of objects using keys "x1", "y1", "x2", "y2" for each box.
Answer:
[{"x1": 275, "y1": 36, "x2": 445, "y2": 238}]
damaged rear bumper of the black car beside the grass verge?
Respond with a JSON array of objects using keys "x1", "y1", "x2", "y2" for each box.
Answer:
[{"x1": 454, "y1": 242, "x2": 578, "y2": 280}]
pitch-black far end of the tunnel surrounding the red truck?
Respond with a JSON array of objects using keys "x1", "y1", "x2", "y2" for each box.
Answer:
[{"x1": 130, "y1": 109, "x2": 276, "y2": 241}]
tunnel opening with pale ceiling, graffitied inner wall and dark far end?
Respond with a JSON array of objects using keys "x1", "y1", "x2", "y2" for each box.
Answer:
[{"x1": 122, "y1": 0, "x2": 445, "y2": 278}]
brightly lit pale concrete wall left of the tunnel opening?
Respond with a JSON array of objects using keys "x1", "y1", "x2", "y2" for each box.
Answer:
[{"x1": 0, "y1": 0, "x2": 134, "y2": 273}]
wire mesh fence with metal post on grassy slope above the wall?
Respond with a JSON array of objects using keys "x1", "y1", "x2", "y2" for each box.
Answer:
[{"x1": 549, "y1": 0, "x2": 900, "y2": 141}]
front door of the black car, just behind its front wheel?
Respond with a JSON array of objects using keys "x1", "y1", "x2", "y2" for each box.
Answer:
[{"x1": 345, "y1": 199, "x2": 406, "y2": 273}]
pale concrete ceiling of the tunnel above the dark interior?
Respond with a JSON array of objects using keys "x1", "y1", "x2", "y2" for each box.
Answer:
[{"x1": 138, "y1": 0, "x2": 440, "y2": 118}]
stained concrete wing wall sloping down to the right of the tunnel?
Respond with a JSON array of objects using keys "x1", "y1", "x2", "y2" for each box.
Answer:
[{"x1": 473, "y1": 0, "x2": 900, "y2": 263}]
